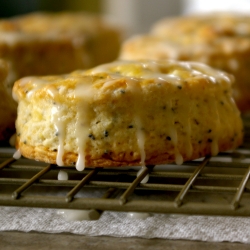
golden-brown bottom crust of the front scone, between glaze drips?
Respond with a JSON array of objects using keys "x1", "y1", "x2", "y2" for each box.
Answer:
[{"x1": 16, "y1": 136, "x2": 242, "y2": 167}]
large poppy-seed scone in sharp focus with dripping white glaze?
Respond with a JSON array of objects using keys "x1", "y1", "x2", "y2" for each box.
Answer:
[{"x1": 13, "y1": 61, "x2": 243, "y2": 170}]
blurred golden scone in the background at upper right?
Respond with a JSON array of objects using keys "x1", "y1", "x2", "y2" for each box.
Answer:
[{"x1": 120, "y1": 13, "x2": 250, "y2": 112}]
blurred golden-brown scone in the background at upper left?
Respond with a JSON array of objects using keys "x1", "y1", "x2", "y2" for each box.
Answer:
[{"x1": 0, "y1": 12, "x2": 122, "y2": 95}]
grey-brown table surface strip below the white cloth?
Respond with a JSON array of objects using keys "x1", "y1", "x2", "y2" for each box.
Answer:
[{"x1": 0, "y1": 232, "x2": 250, "y2": 250}]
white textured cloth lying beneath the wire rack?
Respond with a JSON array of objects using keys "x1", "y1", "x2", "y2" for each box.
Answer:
[{"x1": 0, "y1": 207, "x2": 250, "y2": 243}]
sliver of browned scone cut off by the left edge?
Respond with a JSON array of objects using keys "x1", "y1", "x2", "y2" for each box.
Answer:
[{"x1": 0, "y1": 60, "x2": 16, "y2": 145}]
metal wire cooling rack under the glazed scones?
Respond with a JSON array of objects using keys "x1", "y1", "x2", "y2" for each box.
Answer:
[{"x1": 0, "y1": 118, "x2": 250, "y2": 216}]
